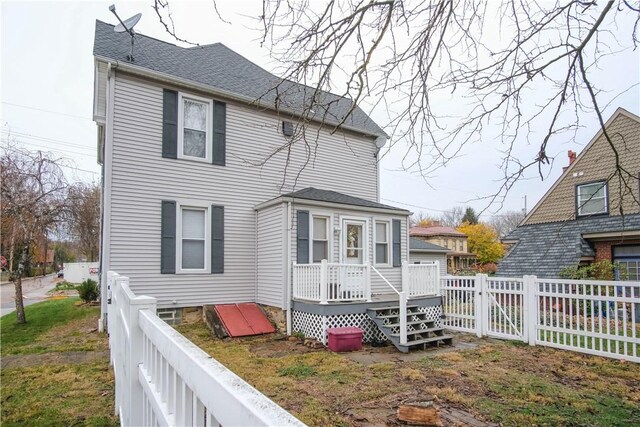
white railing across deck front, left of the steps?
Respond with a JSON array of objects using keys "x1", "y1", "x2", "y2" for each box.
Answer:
[{"x1": 293, "y1": 260, "x2": 371, "y2": 304}]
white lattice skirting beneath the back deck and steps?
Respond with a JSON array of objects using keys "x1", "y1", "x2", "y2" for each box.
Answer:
[{"x1": 292, "y1": 306, "x2": 442, "y2": 345}]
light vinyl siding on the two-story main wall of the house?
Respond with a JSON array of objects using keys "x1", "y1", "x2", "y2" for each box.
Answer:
[{"x1": 105, "y1": 70, "x2": 380, "y2": 308}]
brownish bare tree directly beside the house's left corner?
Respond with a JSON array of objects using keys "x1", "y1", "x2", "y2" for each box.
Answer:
[{"x1": 65, "y1": 183, "x2": 100, "y2": 261}]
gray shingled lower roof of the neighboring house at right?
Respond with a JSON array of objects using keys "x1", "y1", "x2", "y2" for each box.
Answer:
[{"x1": 496, "y1": 214, "x2": 640, "y2": 278}]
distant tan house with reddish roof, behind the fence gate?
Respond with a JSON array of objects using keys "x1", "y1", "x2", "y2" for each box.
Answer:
[{"x1": 409, "y1": 223, "x2": 476, "y2": 274}]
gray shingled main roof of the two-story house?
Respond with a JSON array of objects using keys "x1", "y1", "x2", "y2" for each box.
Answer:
[{"x1": 93, "y1": 21, "x2": 385, "y2": 136}]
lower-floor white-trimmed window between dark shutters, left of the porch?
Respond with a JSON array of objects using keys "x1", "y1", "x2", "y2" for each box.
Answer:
[{"x1": 178, "y1": 206, "x2": 210, "y2": 272}]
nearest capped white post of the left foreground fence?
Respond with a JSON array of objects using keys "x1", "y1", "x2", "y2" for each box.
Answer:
[{"x1": 124, "y1": 278, "x2": 156, "y2": 426}]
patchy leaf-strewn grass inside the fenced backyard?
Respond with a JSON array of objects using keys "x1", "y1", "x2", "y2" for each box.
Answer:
[{"x1": 177, "y1": 323, "x2": 640, "y2": 426}]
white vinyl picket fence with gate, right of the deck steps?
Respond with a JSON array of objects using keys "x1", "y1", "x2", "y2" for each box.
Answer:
[{"x1": 441, "y1": 274, "x2": 640, "y2": 362}]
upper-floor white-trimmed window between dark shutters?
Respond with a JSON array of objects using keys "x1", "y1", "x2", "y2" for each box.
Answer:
[{"x1": 178, "y1": 93, "x2": 213, "y2": 161}]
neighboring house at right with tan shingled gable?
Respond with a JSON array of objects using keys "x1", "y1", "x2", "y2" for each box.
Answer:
[{"x1": 497, "y1": 108, "x2": 640, "y2": 280}]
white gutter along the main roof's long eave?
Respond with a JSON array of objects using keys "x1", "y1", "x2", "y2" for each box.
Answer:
[{"x1": 94, "y1": 55, "x2": 389, "y2": 143}]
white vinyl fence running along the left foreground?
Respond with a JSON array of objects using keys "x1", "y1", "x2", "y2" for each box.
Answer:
[{"x1": 107, "y1": 272, "x2": 304, "y2": 427}]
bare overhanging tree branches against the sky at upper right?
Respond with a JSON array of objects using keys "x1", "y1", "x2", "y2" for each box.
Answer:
[{"x1": 155, "y1": 0, "x2": 640, "y2": 205}]
